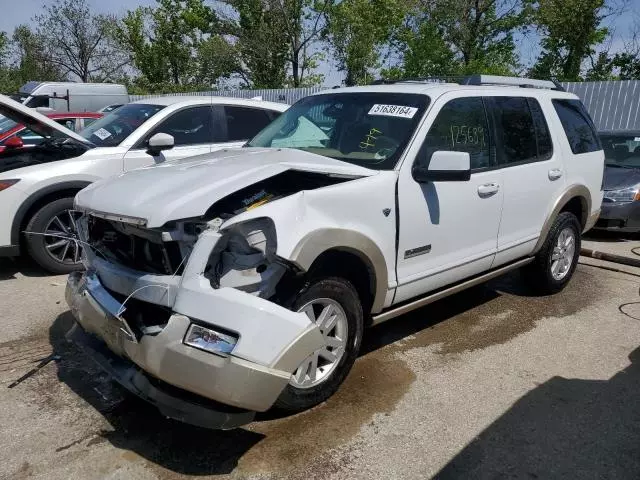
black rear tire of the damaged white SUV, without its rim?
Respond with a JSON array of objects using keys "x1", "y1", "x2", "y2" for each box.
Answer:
[{"x1": 524, "y1": 212, "x2": 582, "y2": 295}]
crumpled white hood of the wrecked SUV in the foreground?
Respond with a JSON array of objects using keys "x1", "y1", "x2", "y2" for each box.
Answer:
[{"x1": 76, "y1": 148, "x2": 378, "y2": 228}]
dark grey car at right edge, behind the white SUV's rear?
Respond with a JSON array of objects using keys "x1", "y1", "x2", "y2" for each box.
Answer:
[{"x1": 594, "y1": 131, "x2": 640, "y2": 233}]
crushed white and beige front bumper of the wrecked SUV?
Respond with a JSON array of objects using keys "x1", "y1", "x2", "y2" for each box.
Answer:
[{"x1": 66, "y1": 272, "x2": 323, "y2": 428}]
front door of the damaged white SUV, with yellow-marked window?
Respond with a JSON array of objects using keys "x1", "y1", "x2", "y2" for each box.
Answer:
[{"x1": 394, "y1": 97, "x2": 503, "y2": 302}]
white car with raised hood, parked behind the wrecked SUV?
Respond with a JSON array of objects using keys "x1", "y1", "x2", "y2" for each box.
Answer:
[{"x1": 0, "y1": 95, "x2": 288, "y2": 273}]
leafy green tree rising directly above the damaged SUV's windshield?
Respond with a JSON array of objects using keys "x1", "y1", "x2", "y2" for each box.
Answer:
[{"x1": 326, "y1": 0, "x2": 406, "y2": 85}]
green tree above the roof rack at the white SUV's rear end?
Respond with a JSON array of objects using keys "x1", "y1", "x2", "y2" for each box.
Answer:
[{"x1": 530, "y1": 0, "x2": 609, "y2": 81}]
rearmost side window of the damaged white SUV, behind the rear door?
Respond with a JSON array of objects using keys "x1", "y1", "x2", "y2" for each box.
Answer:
[{"x1": 553, "y1": 100, "x2": 602, "y2": 154}]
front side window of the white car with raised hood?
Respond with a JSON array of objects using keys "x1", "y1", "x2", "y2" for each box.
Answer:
[{"x1": 147, "y1": 106, "x2": 214, "y2": 146}]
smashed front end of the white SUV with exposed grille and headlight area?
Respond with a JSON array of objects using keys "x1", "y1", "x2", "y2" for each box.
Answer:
[{"x1": 67, "y1": 170, "x2": 358, "y2": 428}]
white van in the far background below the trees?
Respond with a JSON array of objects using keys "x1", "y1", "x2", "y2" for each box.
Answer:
[{"x1": 12, "y1": 82, "x2": 129, "y2": 112}]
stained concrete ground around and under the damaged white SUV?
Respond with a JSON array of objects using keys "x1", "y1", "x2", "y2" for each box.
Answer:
[{"x1": 0, "y1": 238, "x2": 640, "y2": 479}]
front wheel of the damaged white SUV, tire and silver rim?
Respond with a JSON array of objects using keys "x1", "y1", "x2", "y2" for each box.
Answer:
[{"x1": 275, "y1": 277, "x2": 363, "y2": 411}]
